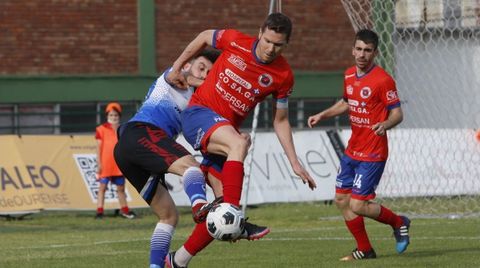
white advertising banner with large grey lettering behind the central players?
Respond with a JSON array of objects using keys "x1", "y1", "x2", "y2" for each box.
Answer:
[{"x1": 167, "y1": 131, "x2": 339, "y2": 205}]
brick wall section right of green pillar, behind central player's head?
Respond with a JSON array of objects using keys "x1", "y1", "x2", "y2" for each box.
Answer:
[{"x1": 156, "y1": 0, "x2": 354, "y2": 71}]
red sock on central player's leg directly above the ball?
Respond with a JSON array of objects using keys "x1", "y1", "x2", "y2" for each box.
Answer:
[{"x1": 222, "y1": 161, "x2": 243, "y2": 206}]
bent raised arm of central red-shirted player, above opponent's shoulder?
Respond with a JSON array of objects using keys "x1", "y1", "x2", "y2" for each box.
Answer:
[{"x1": 167, "y1": 30, "x2": 215, "y2": 89}]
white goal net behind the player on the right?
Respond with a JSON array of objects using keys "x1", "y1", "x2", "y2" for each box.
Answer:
[{"x1": 341, "y1": 0, "x2": 480, "y2": 215}]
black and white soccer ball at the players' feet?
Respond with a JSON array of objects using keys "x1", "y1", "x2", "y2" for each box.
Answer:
[{"x1": 206, "y1": 203, "x2": 245, "y2": 241}]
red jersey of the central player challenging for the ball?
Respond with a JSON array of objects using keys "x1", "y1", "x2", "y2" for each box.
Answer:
[{"x1": 189, "y1": 30, "x2": 293, "y2": 128}]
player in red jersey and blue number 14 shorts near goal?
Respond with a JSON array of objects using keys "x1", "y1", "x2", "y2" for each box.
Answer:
[{"x1": 308, "y1": 30, "x2": 410, "y2": 261}]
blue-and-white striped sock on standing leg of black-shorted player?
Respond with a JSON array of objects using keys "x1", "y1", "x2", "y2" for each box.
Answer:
[{"x1": 150, "y1": 223, "x2": 175, "y2": 268}]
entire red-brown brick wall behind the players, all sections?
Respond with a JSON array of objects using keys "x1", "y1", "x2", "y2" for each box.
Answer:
[{"x1": 0, "y1": 0, "x2": 353, "y2": 75}]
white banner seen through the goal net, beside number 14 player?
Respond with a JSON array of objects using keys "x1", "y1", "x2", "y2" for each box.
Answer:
[{"x1": 340, "y1": 128, "x2": 480, "y2": 197}]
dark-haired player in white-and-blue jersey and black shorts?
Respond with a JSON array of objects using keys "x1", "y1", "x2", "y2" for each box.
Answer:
[{"x1": 114, "y1": 50, "x2": 218, "y2": 268}]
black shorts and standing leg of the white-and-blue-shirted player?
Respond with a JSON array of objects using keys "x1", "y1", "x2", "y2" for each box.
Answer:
[{"x1": 114, "y1": 123, "x2": 182, "y2": 267}]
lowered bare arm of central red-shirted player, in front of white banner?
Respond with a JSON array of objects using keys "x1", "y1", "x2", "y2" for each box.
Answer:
[{"x1": 273, "y1": 102, "x2": 317, "y2": 190}]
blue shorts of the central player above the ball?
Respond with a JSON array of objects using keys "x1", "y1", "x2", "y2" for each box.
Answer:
[{"x1": 180, "y1": 106, "x2": 231, "y2": 153}]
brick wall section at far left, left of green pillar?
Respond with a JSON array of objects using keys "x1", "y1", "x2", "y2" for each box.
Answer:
[{"x1": 0, "y1": 0, "x2": 138, "y2": 74}]
